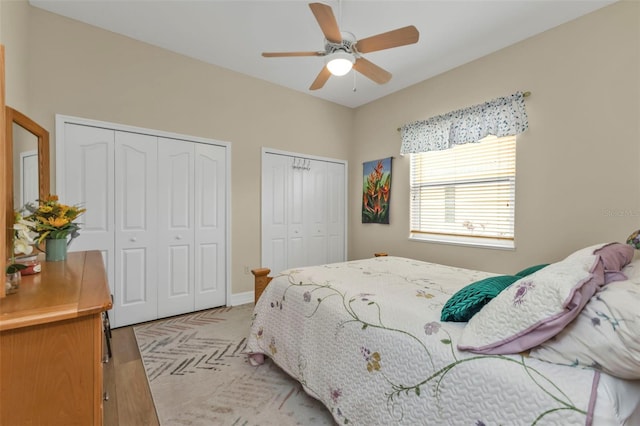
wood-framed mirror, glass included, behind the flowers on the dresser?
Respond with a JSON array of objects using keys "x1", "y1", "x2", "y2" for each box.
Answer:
[{"x1": 5, "y1": 106, "x2": 49, "y2": 254}]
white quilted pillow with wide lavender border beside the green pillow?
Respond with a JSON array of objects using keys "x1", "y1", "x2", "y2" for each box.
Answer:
[{"x1": 458, "y1": 243, "x2": 633, "y2": 354}]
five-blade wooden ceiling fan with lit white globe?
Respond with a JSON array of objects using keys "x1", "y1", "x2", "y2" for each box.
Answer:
[{"x1": 262, "y1": 3, "x2": 419, "y2": 90}]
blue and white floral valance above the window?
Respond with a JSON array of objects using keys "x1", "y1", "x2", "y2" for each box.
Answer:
[{"x1": 400, "y1": 92, "x2": 529, "y2": 154}]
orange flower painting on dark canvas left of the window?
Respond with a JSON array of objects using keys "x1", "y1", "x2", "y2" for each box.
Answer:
[{"x1": 362, "y1": 157, "x2": 392, "y2": 224}]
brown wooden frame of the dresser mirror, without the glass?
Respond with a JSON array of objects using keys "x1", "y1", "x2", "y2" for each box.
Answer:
[{"x1": 5, "y1": 106, "x2": 50, "y2": 254}]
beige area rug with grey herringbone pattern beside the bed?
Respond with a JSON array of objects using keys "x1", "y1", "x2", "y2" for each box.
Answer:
[{"x1": 134, "y1": 304, "x2": 335, "y2": 426}]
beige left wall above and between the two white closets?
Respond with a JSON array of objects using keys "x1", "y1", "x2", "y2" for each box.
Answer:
[{"x1": 3, "y1": 2, "x2": 354, "y2": 294}]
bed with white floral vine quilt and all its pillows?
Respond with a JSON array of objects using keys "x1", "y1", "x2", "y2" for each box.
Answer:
[{"x1": 247, "y1": 243, "x2": 640, "y2": 426}]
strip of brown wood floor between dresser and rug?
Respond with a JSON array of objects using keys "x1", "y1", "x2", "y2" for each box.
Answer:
[{"x1": 104, "y1": 327, "x2": 160, "y2": 426}]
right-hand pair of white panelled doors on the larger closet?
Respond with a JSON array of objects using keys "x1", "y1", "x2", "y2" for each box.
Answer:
[{"x1": 157, "y1": 138, "x2": 226, "y2": 317}]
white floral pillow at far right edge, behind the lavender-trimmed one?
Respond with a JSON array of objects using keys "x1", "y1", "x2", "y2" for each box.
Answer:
[{"x1": 530, "y1": 260, "x2": 640, "y2": 380}]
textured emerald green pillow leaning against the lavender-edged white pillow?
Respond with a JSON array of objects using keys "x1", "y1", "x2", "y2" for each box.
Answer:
[{"x1": 440, "y1": 275, "x2": 522, "y2": 322}]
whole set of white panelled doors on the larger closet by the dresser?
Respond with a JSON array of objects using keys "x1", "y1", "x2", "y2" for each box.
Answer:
[{"x1": 56, "y1": 116, "x2": 230, "y2": 327}]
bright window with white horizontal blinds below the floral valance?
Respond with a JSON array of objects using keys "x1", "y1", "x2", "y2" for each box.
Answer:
[{"x1": 409, "y1": 136, "x2": 516, "y2": 250}]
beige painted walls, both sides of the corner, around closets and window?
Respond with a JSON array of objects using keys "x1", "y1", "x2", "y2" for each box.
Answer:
[{"x1": 0, "y1": 0, "x2": 640, "y2": 293}]
